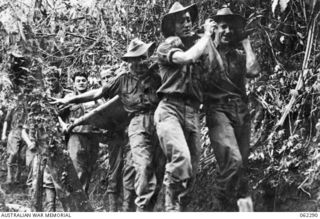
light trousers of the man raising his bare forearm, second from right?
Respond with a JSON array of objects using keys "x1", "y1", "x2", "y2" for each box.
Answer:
[{"x1": 155, "y1": 99, "x2": 201, "y2": 206}]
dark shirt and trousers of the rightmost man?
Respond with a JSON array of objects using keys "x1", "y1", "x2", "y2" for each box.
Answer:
[{"x1": 203, "y1": 44, "x2": 250, "y2": 207}]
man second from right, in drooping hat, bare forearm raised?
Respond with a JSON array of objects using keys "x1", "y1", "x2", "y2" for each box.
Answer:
[{"x1": 155, "y1": 2, "x2": 214, "y2": 211}]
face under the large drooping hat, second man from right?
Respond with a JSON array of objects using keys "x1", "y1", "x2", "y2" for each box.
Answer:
[{"x1": 175, "y1": 12, "x2": 192, "y2": 38}]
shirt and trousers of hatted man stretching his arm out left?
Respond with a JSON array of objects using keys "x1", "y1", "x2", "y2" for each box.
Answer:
[{"x1": 103, "y1": 72, "x2": 164, "y2": 210}]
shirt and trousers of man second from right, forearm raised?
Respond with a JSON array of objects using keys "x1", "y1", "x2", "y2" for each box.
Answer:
[{"x1": 155, "y1": 36, "x2": 208, "y2": 211}]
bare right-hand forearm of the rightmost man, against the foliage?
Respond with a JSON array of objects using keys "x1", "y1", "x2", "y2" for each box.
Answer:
[{"x1": 242, "y1": 38, "x2": 260, "y2": 77}]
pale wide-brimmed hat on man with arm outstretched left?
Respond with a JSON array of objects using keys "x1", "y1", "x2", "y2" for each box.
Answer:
[{"x1": 121, "y1": 38, "x2": 156, "y2": 62}]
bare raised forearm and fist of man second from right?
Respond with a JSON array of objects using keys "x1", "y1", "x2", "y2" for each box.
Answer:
[{"x1": 172, "y1": 19, "x2": 215, "y2": 64}]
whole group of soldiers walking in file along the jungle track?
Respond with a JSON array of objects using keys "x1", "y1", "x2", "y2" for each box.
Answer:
[{"x1": 2, "y1": 2, "x2": 260, "y2": 211}]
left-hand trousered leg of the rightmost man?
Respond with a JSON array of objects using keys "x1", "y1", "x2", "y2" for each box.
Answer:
[{"x1": 207, "y1": 111, "x2": 243, "y2": 211}]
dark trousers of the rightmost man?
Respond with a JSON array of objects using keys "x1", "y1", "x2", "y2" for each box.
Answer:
[{"x1": 206, "y1": 99, "x2": 250, "y2": 198}]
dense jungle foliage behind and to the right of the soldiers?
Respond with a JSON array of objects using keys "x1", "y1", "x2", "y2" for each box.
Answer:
[{"x1": 0, "y1": 0, "x2": 320, "y2": 210}]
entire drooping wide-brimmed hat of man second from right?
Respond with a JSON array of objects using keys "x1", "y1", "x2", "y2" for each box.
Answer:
[{"x1": 161, "y1": 2, "x2": 198, "y2": 37}]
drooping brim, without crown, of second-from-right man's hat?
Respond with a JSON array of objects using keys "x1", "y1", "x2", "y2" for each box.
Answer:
[{"x1": 161, "y1": 4, "x2": 198, "y2": 37}]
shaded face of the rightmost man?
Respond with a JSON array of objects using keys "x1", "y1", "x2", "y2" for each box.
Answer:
[{"x1": 215, "y1": 21, "x2": 235, "y2": 45}]
